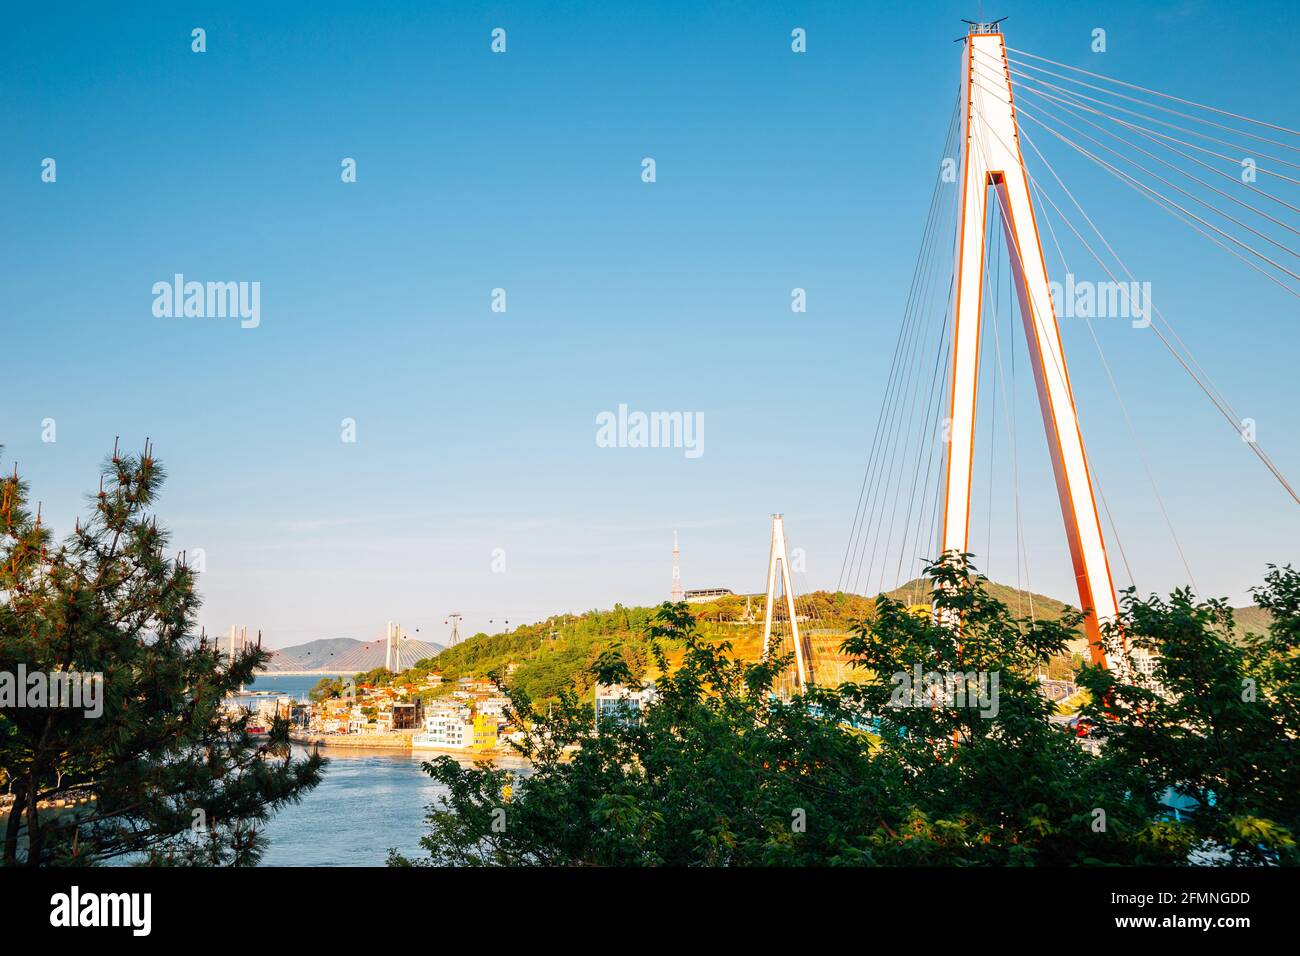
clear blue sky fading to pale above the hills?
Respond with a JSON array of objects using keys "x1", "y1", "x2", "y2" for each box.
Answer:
[{"x1": 0, "y1": 3, "x2": 1300, "y2": 645}]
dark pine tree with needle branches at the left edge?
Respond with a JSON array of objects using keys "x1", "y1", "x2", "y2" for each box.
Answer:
[{"x1": 0, "y1": 449, "x2": 325, "y2": 865}]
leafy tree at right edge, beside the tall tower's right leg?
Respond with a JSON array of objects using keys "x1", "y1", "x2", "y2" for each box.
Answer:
[{"x1": 1080, "y1": 566, "x2": 1300, "y2": 864}]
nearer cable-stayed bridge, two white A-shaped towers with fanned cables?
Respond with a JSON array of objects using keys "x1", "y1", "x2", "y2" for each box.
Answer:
[{"x1": 764, "y1": 22, "x2": 1300, "y2": 685}]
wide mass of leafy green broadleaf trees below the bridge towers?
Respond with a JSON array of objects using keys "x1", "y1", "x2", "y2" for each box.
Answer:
[{"x1": 390, "y1": 555, "x2": 1300, "y2": 865}]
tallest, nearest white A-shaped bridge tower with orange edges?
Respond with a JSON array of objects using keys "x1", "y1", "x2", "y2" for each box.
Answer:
[{"x1": 941, "y1": 23, "x2": 1118, "y2": 663}]
